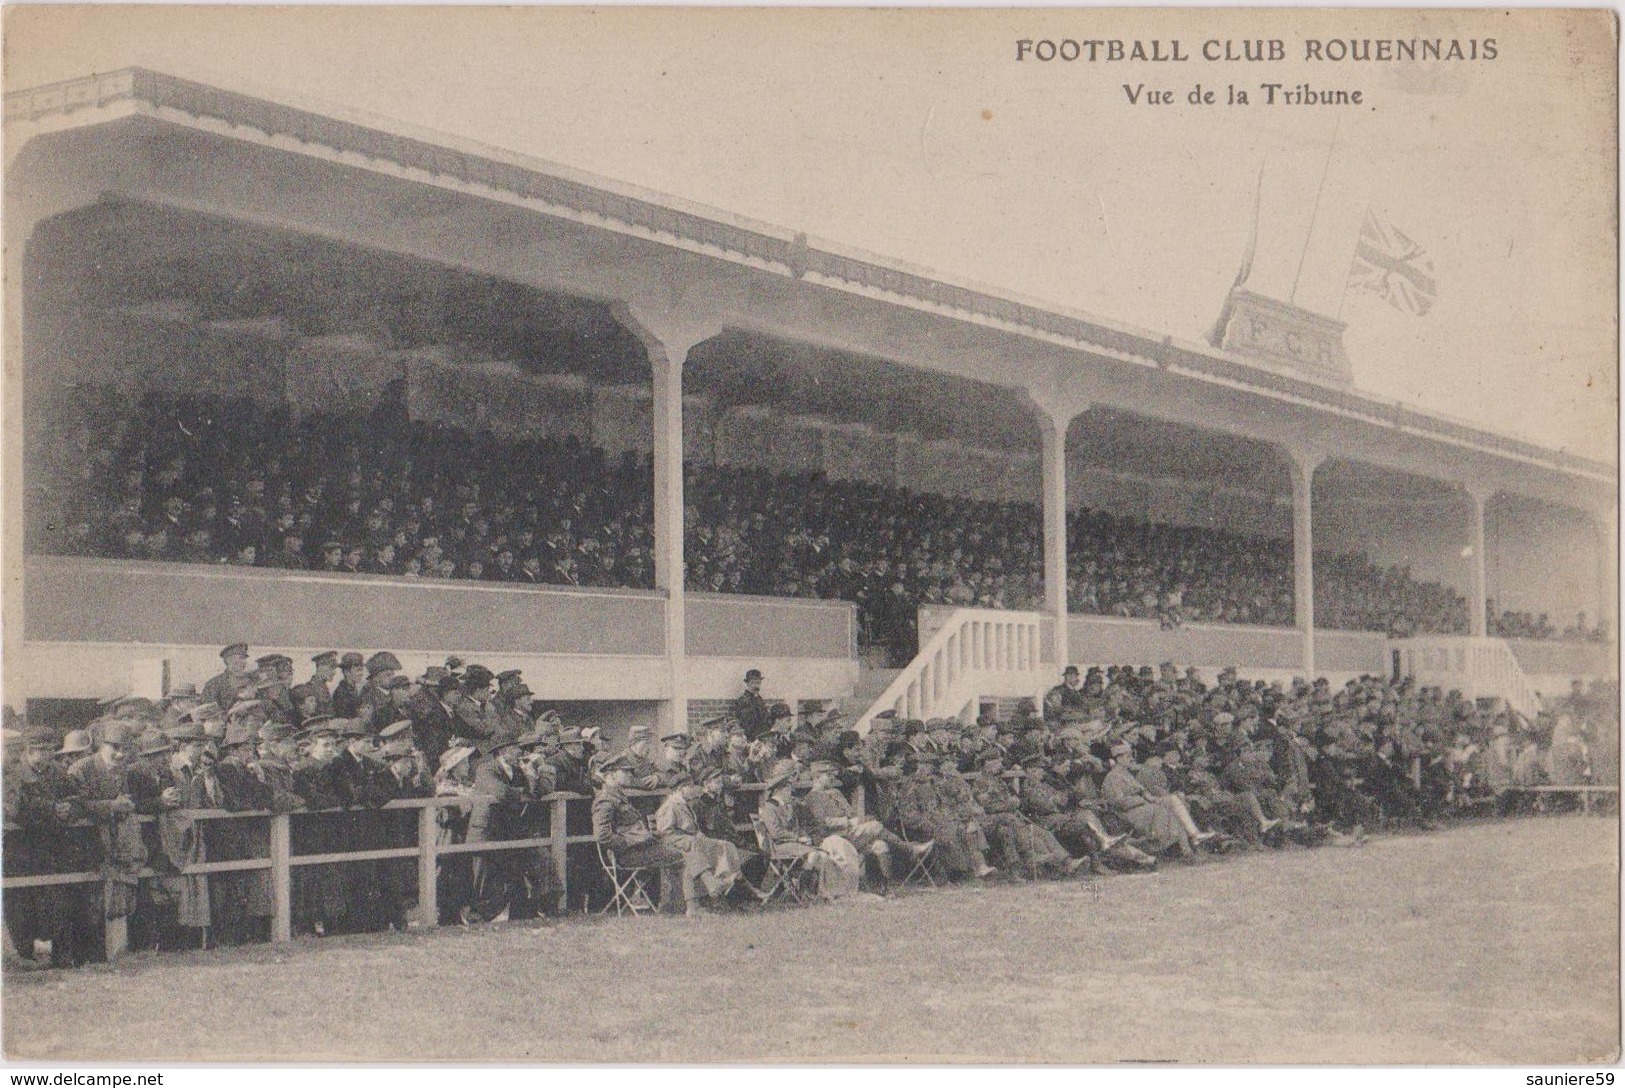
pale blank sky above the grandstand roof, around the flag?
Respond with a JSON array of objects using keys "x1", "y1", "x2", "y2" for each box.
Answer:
[{"x1": 5, "y1": 6, "x2": 1619, "y2": 461}]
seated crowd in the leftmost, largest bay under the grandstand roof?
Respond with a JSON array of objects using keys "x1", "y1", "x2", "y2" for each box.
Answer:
[{"x1": 31, "y1": 389, "x2": 653, "y2": 586}]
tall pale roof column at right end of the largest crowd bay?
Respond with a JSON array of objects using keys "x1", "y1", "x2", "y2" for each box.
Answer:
[{"x1": 614, "y1": 305, "x2": 722, "y2": 736}]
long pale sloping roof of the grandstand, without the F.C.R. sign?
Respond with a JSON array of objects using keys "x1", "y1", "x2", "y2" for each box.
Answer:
[{"x1": 5, "y1": 68, "x2": 1617, "y2": 516}]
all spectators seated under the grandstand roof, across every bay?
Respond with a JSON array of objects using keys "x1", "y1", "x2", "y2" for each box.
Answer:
[{"x1": 29, "y1": 390, "x2": 1606, "y2": 664}]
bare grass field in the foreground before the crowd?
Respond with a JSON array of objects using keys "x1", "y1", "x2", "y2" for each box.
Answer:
[{"x1": 3, "y1": 817, "x2": 1620, "y2": 1064}]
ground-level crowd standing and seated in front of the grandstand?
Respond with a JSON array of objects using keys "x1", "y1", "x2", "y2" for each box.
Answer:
[{"x1": 3, "y1": 645, "x2": 1619, "y2": 966}]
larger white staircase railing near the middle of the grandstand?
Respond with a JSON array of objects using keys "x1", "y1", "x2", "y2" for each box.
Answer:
[{"x1": 855, "y1": 609, "x2": 1043, "y2": 734}]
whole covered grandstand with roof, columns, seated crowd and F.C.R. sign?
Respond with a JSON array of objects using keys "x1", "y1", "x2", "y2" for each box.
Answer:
[{"x1": 5, "y1": 70, "x2": 1617, "y2": 740}]
